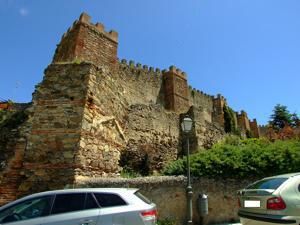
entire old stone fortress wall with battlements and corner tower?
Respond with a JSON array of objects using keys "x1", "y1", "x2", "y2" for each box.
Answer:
[{"x1": 0, "y1": 13, "x2": 259, "y2": 205}]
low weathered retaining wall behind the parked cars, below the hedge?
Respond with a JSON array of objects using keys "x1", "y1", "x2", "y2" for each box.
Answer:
[{"x1": 74, "y1": 176, "x2": 251, "y2": 225}]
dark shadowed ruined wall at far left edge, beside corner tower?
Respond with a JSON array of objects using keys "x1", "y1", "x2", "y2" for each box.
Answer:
[{"x1": 0, "y1": 105, "x2": 32, "y2": 206}]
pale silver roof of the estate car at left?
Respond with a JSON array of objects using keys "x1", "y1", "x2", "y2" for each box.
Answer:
[{"x1": 0, "y1": 188, "x2": 139, "y2": 209}]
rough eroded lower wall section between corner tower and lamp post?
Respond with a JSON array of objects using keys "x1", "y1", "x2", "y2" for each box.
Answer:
[{"x1": 121, "y1": 104, "x2": 180, "y2": 175}]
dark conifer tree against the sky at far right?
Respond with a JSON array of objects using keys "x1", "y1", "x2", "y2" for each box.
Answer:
[{"x1": 269, "y1": 104, "x2": 299, "y2": 130}]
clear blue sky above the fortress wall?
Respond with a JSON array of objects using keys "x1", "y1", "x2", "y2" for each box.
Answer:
[{"x1": 0, "y1": 0, "x2": 300, "y2": 124}]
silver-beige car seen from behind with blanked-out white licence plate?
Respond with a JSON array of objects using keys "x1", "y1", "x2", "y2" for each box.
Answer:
[{"x1": 238, "y1": 173, "x2": 300, "y2": 225}]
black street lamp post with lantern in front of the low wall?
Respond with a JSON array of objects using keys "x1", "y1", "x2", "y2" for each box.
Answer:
[{"x1": 181, "y1": 117, "x2": 193, "y2": 225}]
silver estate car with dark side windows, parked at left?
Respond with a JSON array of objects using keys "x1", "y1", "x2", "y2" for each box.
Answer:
[{"x1": 0, "y1": 188, "x2": 157, "y2": 225}]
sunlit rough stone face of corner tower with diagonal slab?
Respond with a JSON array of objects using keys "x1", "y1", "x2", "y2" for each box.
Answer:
[{"x1": 76, "y1": 62, "x2": 128, "y2": 179}]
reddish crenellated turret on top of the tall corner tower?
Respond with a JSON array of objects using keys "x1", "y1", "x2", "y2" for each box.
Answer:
[{"x1": 53, "y1": 13, "x2": 118, "y2": 69}]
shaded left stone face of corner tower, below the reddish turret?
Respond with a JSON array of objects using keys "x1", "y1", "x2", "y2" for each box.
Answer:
[{"x1": 19, "y1": 63, "x2": 91, "y2": 195}]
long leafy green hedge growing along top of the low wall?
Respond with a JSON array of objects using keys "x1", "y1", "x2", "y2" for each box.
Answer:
[{"x1": 163, "y1": 139, "x2": 300, "y2": 178}]
